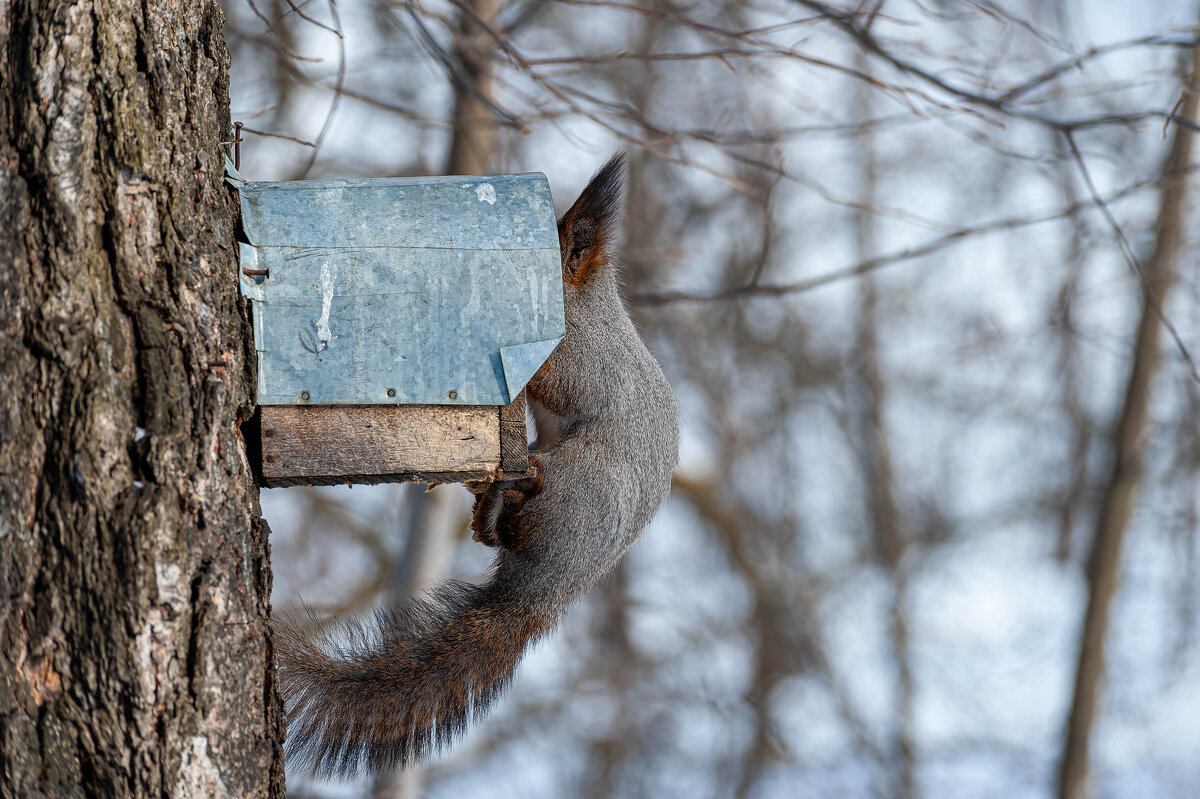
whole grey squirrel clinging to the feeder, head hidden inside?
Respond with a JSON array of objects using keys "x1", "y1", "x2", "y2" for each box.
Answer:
[{"x1": 275, "y1": 154, "x2": 679, "y2": 776}]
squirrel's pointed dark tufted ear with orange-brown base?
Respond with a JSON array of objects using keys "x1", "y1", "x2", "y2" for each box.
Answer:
[{"x1": 558, "y1": 152, "x2": 625, "y2": 286}]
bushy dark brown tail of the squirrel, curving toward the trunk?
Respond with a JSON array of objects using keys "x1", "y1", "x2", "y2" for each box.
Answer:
[{"x1": 275, "y1": 579, "x2": 554, "y2": 776}]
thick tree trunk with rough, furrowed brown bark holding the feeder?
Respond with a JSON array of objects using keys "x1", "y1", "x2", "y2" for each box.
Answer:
[{"x1": 0, "y1": 0, "x2": 283, "y2": 798}]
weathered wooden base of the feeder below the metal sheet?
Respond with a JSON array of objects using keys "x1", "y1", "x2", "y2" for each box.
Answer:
[{"x1": 252, "y1": 394, "x2": 528, "y2": 486}]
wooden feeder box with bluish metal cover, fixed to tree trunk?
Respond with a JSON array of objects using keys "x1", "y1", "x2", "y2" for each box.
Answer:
[{"x1": 226, "y1": 162, "x2": 565, "y2": 486}]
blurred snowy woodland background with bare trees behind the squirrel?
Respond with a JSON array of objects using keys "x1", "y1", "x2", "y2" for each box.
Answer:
[{"x1": 227, "y1": 0, "x2": 1200, "y2": 799}]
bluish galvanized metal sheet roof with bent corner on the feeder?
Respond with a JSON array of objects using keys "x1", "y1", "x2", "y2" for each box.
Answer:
[{"x1": 226, "y1": 162, "x2": 565, "y2": 404}]
